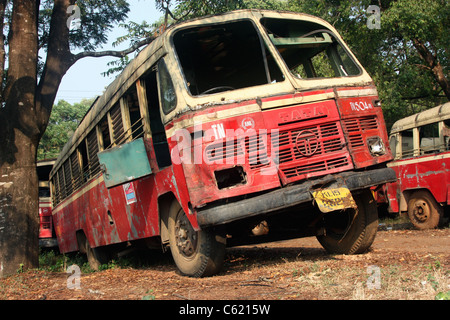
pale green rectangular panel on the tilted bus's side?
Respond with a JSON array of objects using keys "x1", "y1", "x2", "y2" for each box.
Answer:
[{"x1": 98, "y1": 138, "x2": 152, "y2": 188}]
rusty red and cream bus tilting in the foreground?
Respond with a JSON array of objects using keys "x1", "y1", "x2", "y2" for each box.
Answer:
[{"x1": 51, "y1": 10, "x2": 395, "y2": 276}]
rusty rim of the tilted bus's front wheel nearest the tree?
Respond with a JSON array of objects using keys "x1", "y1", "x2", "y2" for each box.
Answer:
[{"x1": 175, "y1": 210, "x2": 198, "y2": 258}]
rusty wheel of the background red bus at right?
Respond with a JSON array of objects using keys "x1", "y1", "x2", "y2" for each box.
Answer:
[{"x1": 408, "y1": 190, "x2": 443, "y2": 230}]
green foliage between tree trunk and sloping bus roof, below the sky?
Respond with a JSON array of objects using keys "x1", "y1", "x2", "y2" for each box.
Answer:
[{"x1": 38, "y1": 99, "x2": 94, "y2": 160}]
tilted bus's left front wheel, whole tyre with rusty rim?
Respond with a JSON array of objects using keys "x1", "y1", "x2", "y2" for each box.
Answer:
[{"x1": 168, "y1": 201, "x2": 225, "y2": 277}]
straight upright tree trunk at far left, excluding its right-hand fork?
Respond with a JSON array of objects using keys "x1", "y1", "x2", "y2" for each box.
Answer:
[{"x1": 0, "y1": 0, "x2": 41, "y2": 277}]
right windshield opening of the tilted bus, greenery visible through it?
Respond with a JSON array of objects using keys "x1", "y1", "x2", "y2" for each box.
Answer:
[{"x1": 261, "y1": 18, "x2": 361, "y2": 79}]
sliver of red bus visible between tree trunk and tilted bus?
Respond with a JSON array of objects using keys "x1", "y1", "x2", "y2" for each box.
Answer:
[{"x1": 36, "y1": 159, "x2": 58, "y2": 247}]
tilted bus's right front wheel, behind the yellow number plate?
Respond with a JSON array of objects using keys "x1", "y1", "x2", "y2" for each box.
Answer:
[{"x1": 317, "y1": 191, "x2": 378, "y2": 254}]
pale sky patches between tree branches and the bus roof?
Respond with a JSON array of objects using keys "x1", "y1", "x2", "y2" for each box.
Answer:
[{"x1": 55, "y1": 0, "x2": 162, "y2": 104}]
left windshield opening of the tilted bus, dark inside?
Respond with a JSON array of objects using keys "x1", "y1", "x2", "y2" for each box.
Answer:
[{"x1": 173, "y1": 20, "x2": 284, "y2": 96}]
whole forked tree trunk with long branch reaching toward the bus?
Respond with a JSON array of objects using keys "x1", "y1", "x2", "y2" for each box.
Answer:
[{"x1": 0, "y1": 0, "x2": 148, "y2": 278}]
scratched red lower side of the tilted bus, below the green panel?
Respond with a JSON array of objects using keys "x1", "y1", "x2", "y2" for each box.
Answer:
[{"x1": 54, "y1": 176, "x2": 159, "y2": 252}]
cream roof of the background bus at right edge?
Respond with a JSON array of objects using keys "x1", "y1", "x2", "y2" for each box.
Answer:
[{"x1": 391, "y1": 102, "x2": 450, "y2": 134}]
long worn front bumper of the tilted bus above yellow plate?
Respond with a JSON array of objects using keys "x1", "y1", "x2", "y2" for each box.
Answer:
[{"x1": 197, "y1": 168, "x2": 397, "y2": 228}]
